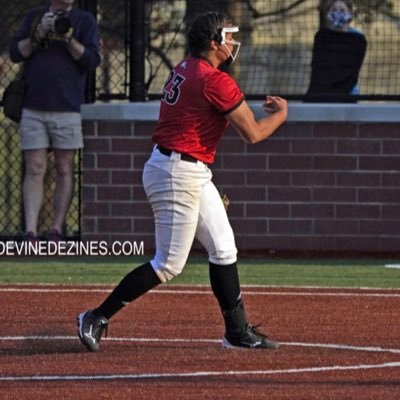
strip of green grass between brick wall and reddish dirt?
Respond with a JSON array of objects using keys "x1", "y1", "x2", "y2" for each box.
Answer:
[{"x1": 0, "y1": 257, "x2": 400, "y2": 288}]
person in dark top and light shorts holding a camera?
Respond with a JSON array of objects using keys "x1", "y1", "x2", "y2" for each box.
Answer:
[{"x1": 10, "y1": 0, "x2": 100, "y2": 241}]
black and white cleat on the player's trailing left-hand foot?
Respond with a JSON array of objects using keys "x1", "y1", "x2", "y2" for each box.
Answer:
[{"x1": 76, "y1": 310, "x2": 108, "y2": 351}]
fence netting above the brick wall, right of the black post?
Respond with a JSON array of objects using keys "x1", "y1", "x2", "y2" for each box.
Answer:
[{"x1": 146, "y1": 0, "x2": 400, "y2": 100}]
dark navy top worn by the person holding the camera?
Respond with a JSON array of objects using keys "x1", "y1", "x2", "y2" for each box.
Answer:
[{"x1": 10, "y1": 9, "x2": 100, "y2": 112}]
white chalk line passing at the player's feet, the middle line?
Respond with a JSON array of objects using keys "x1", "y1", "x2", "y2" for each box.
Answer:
[{"x1": 0, "y1": 335, "x2": 400, "y2": 354}]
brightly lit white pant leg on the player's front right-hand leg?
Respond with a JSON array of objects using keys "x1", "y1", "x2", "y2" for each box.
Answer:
[{"x1": 196, "y1": 181, "x2": 237, "y2": 265}]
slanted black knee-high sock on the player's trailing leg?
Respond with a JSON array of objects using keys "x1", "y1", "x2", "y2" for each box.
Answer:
[{"x1": 93, "y1": 262, "x2": 161, "y2": 319}]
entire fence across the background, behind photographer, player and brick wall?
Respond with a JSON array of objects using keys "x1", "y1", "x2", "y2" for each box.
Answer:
[{"x1": 0, "y1": 0, "x2": 400, "y2": 241}]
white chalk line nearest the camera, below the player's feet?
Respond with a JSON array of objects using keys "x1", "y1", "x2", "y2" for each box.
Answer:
[{"x1": 0, "y1": 362, "x2": 400, "y2": 382}]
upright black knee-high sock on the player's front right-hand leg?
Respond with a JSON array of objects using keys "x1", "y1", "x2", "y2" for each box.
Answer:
[{"x1": 209, "y1": 262, "x2": 240, "y2": 311}]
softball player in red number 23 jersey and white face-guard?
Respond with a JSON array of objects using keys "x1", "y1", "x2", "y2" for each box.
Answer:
[{"x1": 77, "y1": 12, "x2": 287, "y2": 351}]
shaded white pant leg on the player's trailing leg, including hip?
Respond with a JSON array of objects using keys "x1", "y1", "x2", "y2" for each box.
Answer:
[{"x1": 143, "y1": 149, "x2": 211, "y2": 282}]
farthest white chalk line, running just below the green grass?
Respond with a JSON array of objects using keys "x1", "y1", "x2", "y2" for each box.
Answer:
[{"x1": 0, "y1": 287, "x2": 400, "y2": 298}]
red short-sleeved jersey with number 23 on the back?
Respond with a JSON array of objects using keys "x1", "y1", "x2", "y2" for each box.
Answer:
[{"x1": 153, "y1": 57, "x2": 244, "y2": 164}]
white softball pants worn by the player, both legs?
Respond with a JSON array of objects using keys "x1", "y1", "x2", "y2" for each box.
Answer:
[{"x1": 143, "y1": 148, "x2": 237, "y2": 282}]
